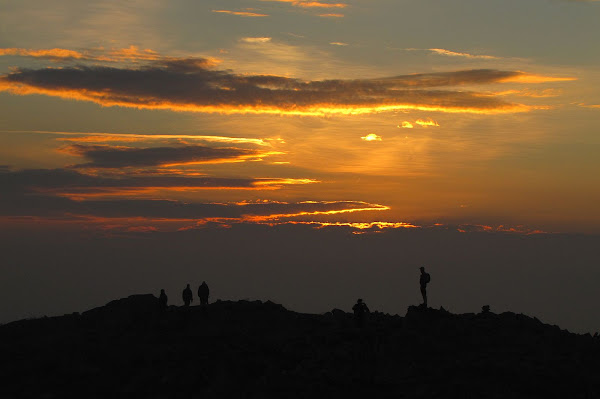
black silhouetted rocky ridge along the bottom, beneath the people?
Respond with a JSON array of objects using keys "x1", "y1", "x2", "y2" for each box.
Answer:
[{"x1": 0, "y1": 295, "x2": 600, "y2": 398}]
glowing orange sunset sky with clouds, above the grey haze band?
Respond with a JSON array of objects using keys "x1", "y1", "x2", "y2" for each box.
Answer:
[{"x1": 0, "y1": 0, "x2": 600, "y2": 332}]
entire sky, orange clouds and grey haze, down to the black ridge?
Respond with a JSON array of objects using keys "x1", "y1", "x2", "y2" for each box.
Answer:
[{"x1": 0, "y1": 0, "x2": 600, "y2": 331}]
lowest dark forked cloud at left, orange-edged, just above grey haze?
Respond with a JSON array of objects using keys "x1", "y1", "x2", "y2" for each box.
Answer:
[{"x1": 0, "y1": 169, "x2": 378, "y2": 226}]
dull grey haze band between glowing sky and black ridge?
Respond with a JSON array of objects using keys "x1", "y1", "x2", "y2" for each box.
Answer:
[{"x1": 0, "y1": 225, "x2": 600, "y2": 332}]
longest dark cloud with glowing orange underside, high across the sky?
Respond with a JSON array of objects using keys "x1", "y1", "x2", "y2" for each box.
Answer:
[{"x1": 0, "y1": 52, "x2": 574, "y2": 116}]
